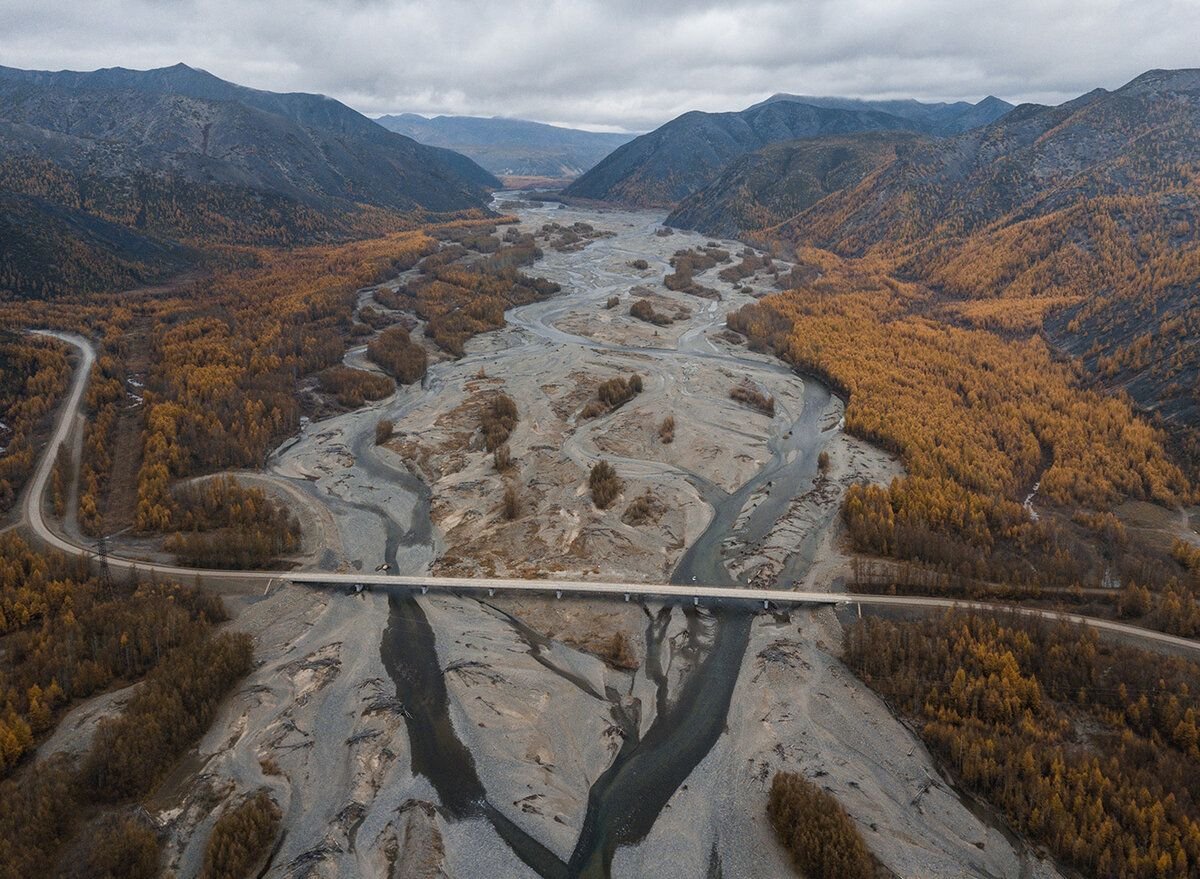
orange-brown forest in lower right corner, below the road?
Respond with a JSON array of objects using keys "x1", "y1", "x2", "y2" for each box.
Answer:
[{"x1": 845, "y1": 614, "x2": 1200, "y2": 879}]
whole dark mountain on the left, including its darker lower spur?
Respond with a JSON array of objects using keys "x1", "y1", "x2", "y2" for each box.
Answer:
[{"x1": 0, "y1": 65, "x2": 498, "y2": 295}]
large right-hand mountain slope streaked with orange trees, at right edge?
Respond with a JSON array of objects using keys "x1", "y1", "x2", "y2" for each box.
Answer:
[{"x1": 778, "y1": 70, "x2": 1200, "y2": 461}]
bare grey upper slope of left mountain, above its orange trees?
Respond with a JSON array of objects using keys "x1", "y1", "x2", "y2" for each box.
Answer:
[{"x1": 0, "y1": 65, "x2": 496, "y2": 210}]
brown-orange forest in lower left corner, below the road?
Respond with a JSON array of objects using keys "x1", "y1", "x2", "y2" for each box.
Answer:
[{"x1": 0, "y1": 534, "x2": 253, "y2": 879}]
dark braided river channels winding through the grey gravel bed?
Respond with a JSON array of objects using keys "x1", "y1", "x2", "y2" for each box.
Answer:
[{"x1": 355, "y1": 195, "x2": 834, "y2": 879}]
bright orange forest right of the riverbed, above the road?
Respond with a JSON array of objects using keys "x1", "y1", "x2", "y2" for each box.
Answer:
[{"x1": 728, "y1": 243, "x2": 1200, "y2": 636}]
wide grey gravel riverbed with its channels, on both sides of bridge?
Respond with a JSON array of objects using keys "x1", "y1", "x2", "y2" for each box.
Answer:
[{"x1": 49, "y1": 193, "x2": 1056, "y2": 879}]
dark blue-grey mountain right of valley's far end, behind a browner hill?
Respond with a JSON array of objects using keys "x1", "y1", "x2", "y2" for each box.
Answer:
[{"x1": 564, "y1": 101, "x2": 918, "y2": 207}]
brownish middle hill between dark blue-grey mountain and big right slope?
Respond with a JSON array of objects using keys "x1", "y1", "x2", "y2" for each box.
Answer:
[{"x1": 666, "y1": 131, "x2": 925, "y2": 238}]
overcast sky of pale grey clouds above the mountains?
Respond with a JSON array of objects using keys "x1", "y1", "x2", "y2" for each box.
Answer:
[{"x1": 0, "y1": 0, "x2": 1200, "y2": 131}]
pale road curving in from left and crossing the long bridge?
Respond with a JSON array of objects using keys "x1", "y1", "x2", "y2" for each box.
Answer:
[{"x1": 22, "y1": 330, "x2": 1200, "y2": 654}]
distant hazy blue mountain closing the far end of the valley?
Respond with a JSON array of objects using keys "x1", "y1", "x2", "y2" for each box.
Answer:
[{"x1": 376, "y1": 113, "x2": 636, "y2": 178}]
